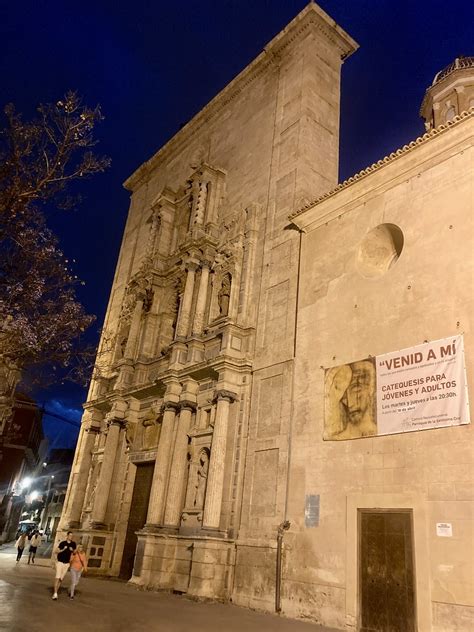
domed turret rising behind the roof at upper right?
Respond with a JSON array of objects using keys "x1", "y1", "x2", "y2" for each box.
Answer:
[{"x1": 420, "y1": 57, "x2": 474, "y2": 130}]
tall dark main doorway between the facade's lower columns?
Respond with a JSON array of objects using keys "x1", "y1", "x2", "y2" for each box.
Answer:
[{"x1": 120, "y1": 463, "x2": 155, "y2": 579}]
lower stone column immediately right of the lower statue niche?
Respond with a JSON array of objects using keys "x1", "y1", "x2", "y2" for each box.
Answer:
[{"x1": 202, "y1": 390, "x2": 237, "y2": 529}]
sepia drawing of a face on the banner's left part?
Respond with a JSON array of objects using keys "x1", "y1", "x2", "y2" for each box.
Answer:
[{"x1": 324, "y1": 358, "x2": 377, "y2": 441}]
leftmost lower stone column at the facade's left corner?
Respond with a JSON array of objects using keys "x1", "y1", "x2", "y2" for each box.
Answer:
[{"x1": 63, "y1": 411, "x2": 102, "y2": 529}]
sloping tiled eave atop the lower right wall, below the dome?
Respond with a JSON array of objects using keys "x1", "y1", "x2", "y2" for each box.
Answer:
[{"x1": 288, "y1": 108, "x2": 474, "y2": 223}]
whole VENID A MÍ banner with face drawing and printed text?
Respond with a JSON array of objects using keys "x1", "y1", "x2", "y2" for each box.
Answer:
[{"x1": 324, "y1": 335, "x2": 470, "y2": 441}]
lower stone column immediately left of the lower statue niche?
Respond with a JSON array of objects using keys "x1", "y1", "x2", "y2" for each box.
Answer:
[{"x1": 163, "y1": 379, "x2": 198, "y2": 528}]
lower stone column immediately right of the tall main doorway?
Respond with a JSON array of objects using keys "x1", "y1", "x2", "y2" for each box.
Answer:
[{"x1": 146, "y1": 380, "x2": 181, "y2": 530}]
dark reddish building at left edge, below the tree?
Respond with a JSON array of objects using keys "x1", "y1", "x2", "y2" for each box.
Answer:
[{"x1": 0, "y1": 394, "x2": 47, "y2": 542}]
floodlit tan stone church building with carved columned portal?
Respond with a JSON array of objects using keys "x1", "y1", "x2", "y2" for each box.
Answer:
[{"x1": 61, "y1": 4, "x2": 474, "y2": 632}]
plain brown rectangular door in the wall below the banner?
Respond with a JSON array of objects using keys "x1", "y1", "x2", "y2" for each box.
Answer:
[{"x1": 359, "y1": 510, "x2": 416, "y2": 632}]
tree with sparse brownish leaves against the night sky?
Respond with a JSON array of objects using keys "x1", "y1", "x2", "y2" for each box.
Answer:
[{"x1": 0, "y1": 92, "x2": 110, "y2": 429}]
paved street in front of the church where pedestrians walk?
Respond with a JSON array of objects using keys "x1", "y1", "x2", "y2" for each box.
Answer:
[{"x1": 0, "y1": 546, "x2": 336, "y2": 632}]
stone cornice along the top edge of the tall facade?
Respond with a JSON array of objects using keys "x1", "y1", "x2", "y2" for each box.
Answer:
[{"x1": 124, "y1": 2, "x2": 358, "y2": 191}]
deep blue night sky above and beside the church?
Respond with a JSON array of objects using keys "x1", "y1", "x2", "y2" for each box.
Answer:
[{"x1": 0, "y1": 0, "x2": 474, "y2": 447}]
